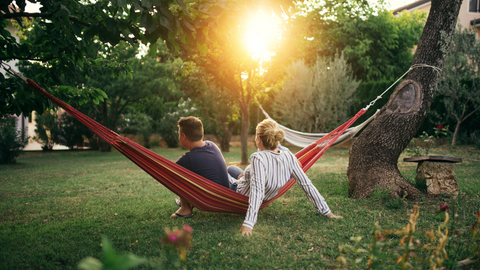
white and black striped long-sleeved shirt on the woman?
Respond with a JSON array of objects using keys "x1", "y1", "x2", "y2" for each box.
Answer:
[{"x1": 234, "y1": 146, "x2": 330, "y2": 229}]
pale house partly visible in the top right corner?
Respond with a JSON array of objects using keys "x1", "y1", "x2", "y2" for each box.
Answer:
[{"x1": 393, "y1": 0, "x2": 480, "y2": 39}]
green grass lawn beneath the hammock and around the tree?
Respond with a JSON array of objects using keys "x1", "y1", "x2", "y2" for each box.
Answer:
[{"x1": 0, "y1": 144, "x2": 480, "y2": 269}]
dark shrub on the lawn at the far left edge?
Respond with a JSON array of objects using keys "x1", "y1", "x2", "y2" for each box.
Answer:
[{"x1": 0, "y1": 116, "x2": 27, "y2": 164}]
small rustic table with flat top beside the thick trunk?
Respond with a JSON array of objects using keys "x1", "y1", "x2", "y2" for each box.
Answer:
[{"x1": 403, "y1": 156, "x2": 462, "y2": 195}]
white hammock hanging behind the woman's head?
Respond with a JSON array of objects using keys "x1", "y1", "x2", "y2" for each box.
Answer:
[{"x1": 257, "y1": 104, "x2": 379, "y2": 147}]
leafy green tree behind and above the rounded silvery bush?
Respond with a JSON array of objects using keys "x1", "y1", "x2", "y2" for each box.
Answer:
[{"x1": 286, "y1": 0, "x2": 426, "y2": 81}]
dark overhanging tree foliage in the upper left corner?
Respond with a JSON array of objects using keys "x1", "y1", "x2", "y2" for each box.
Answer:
[{"x1": 0, "y1": 0, "x2": 201, "y2": 114}]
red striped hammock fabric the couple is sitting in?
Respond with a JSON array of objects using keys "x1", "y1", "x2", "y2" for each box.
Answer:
[{"x1": 25, "y1": 79, "x2": 366, "y2": 213}]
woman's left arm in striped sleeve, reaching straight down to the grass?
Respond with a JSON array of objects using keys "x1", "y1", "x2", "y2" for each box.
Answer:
[{"x1": 242, "y1": 155, "x2": 266, "y2": 234}]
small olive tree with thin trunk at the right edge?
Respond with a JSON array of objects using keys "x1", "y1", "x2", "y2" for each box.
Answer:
[{"x1": 437, "y1": 25, "x2": 480, "y2": 146}]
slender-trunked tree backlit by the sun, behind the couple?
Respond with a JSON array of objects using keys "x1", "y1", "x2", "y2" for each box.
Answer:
[{"x1": 181, "y1": 0, "x2": 291, "y2": 164}]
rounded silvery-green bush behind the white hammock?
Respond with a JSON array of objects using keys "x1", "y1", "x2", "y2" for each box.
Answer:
[{"x1": 274, "y1": 52, "x2": 360, "y2": 132}]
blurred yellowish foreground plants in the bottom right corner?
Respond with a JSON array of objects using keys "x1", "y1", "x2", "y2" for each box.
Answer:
[{"x1": 337, "y1": 204, "x2": 480, "y2": 269}]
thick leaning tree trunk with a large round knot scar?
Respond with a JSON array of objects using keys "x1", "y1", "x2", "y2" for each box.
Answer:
[{"x1": 347, "y1": 0, "x2": 462, "y2": 200}]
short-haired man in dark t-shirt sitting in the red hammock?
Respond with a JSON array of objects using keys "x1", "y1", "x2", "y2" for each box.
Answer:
[{"x1": 172, "y1": 116, "x2": 230, "y2": 218}]
